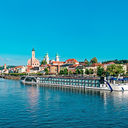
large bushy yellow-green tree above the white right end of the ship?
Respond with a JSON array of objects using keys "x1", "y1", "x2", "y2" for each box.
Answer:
[{"x1": 107, "y1": 64, "x2": 124, "y2": 76}]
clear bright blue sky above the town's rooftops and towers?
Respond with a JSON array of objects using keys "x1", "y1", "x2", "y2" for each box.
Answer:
[{"x1": 0, "y1": 0, "x2": 128, "y2": 65}]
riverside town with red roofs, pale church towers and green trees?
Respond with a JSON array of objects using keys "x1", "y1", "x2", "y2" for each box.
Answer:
[{"x1": 0, "y1": 48, "x2": 128, "y2": 76}]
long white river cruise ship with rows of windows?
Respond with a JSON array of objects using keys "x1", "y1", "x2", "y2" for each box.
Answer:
[{"x1": 21, "y1": 76, "x2": 128, "y2": 91}]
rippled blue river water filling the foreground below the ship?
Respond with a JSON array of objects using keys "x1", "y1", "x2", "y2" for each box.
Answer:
[{"x1": 0, "y1": 79, "x2": 128, "y2": 128}]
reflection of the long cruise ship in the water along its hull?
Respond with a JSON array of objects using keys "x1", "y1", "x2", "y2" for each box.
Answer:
[{"x1": 34, "y1": 86, "x2": 128, "y2": 107}]
